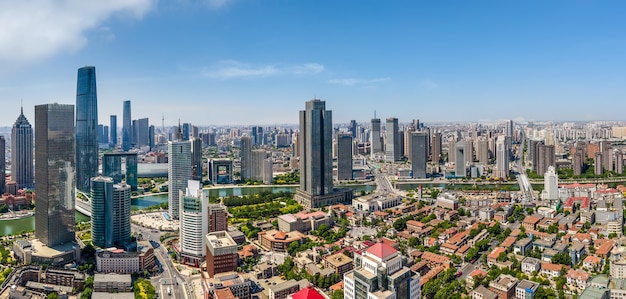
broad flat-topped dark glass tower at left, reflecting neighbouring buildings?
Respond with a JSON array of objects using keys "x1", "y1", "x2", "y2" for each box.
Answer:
[{"x1": 35, "y1": 103, "x2": 76, "y2": 247}]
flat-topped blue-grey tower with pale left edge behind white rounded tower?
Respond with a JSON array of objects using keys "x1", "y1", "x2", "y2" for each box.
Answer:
[{"x1": 167, "y1": 141, "x2": 191, "y2": 219}]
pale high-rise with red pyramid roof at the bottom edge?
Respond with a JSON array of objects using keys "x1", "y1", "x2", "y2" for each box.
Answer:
[{"x1": 343, "y1": 242, "x2": 421, "y2": 299}]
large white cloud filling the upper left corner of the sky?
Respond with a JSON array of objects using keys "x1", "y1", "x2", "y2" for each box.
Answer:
[{"x1": 0, "y1": 0, "x2": 156, "y2": 63}]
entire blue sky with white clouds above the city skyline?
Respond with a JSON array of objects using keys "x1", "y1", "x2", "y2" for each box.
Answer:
[{"x1": 0, "y1": 0, "x2": 626, "y2": 125}]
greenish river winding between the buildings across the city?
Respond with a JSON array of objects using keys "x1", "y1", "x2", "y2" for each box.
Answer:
[{"x1": 0, "y1": 185, "x2": 376, "y2": 236}]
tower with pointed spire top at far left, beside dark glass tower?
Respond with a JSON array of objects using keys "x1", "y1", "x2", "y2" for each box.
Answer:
[{"x1": 11, "y1": 108, "x2": 34, "y2": 189}]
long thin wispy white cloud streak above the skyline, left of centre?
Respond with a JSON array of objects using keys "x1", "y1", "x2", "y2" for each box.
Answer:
[{"x1": 202, "y1": 60, "x2": 324, "y2": 80}]
